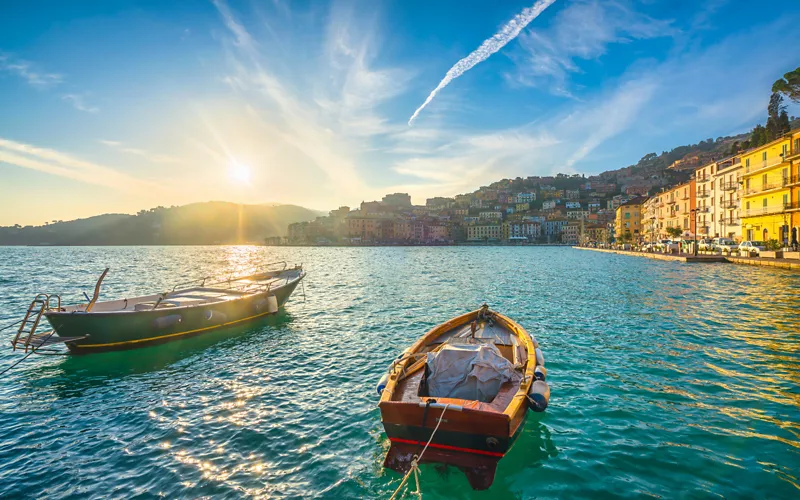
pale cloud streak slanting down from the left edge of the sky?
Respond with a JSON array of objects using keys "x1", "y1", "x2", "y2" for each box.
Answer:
[{"x1": 0, "y1": 138, "x2": 159, "y2": 193}]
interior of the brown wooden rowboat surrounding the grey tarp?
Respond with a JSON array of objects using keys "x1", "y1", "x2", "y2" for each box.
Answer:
[{"x1": 391, "y1": 317, "x2": 528, "y2": 413}]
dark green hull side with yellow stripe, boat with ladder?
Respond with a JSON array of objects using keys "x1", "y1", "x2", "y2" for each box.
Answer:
[{"x1": 46, "y1": 278, "x2": 302, "y2": 354}]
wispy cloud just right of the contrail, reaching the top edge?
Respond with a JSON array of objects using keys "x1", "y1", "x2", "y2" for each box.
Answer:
[{"x1": 506, "y1": 0, "x2": 677, "y2": 97}]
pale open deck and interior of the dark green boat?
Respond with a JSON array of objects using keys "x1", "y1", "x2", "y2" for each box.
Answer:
[{"x1": 52, "y1": 269, "x2": 301, "y2": 313}]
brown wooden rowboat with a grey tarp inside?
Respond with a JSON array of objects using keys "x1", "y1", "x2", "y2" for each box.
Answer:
[{"x1": 378, "y1": 305, "x2": 550, "y2": 489}]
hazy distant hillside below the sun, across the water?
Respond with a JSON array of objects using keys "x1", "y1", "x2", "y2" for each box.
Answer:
[{"x1": 0, "y1": 201, "x2": 319, "y2": 245}]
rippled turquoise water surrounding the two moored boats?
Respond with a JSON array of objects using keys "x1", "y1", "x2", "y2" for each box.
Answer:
[{"x1": 0, "y1": 247, "x2": 800, "y2": 499}]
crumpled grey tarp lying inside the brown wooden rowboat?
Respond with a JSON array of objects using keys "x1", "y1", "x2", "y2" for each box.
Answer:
[{"x1": 427, "y1": 344, "x2": 514, "y2": 403}]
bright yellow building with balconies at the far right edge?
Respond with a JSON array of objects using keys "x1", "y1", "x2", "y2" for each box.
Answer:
[{"x1": 741, "y1": 130, "x2": 800, "y2": 243}]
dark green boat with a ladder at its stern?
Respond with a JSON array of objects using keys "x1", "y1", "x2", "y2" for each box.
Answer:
[{"x1": 12, "y1": 262, "x2": 305, "y2": 354}]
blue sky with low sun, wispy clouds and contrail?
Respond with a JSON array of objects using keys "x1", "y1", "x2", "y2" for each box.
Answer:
[{"x1": 0, "y1": 0, "x2": 800, "y2": 225}]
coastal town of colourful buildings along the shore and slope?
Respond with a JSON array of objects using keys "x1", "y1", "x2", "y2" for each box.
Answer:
[{"x1": 290, "y1": 129, "x2": 800, "y2": 247}]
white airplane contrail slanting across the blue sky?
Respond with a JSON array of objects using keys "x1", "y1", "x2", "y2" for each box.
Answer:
[{"x1": 408, "y1": 0, "x2": 556, "y2": 127}]
